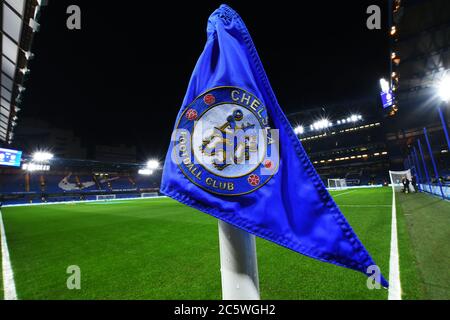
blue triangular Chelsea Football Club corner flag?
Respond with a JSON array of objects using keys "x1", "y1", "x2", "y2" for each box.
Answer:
[{"x1": 161, "y1": 5, "x2": 388, "y2": 287}]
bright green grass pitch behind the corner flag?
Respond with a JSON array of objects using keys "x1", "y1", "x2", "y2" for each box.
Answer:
[{"x1": 0, "y1": 188, "x2": 428, "y2": 299}]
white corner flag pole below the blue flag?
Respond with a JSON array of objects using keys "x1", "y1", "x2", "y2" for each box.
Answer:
[{"x1": 219, "y1": 220, "x2": 259, "y2": 300}]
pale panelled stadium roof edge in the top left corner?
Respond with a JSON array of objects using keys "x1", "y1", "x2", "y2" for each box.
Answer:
[{"x1": 0, "y1": 0, "x2": 46, "y2": 143}]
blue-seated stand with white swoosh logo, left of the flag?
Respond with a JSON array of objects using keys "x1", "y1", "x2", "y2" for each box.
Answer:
[{"x1": 0, "y1": 159, "x2": 161, "y2": 204}]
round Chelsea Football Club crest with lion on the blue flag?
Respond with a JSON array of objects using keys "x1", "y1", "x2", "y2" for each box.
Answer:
[{"x1": 173, "y1": 87, "x2": 278, "y2": 196}]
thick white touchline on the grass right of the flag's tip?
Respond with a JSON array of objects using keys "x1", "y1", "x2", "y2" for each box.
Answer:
[{"x1": 388, "y1": 188, "x2": 402, "y2": 300}]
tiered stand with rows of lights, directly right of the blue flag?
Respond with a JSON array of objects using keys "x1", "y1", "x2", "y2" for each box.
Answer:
[{"x1": 289, "y1": 99, "x2": 389, "y2": 186}]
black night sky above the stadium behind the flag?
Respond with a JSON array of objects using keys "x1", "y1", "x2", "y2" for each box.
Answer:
[{"x1": 18, "y1": 0, "x2": 388, "y2": 158}]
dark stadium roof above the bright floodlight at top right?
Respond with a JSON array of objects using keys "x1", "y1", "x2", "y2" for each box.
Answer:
[{"x1": 392, "y1": 0, "x2": 450, "y2": 98}]
